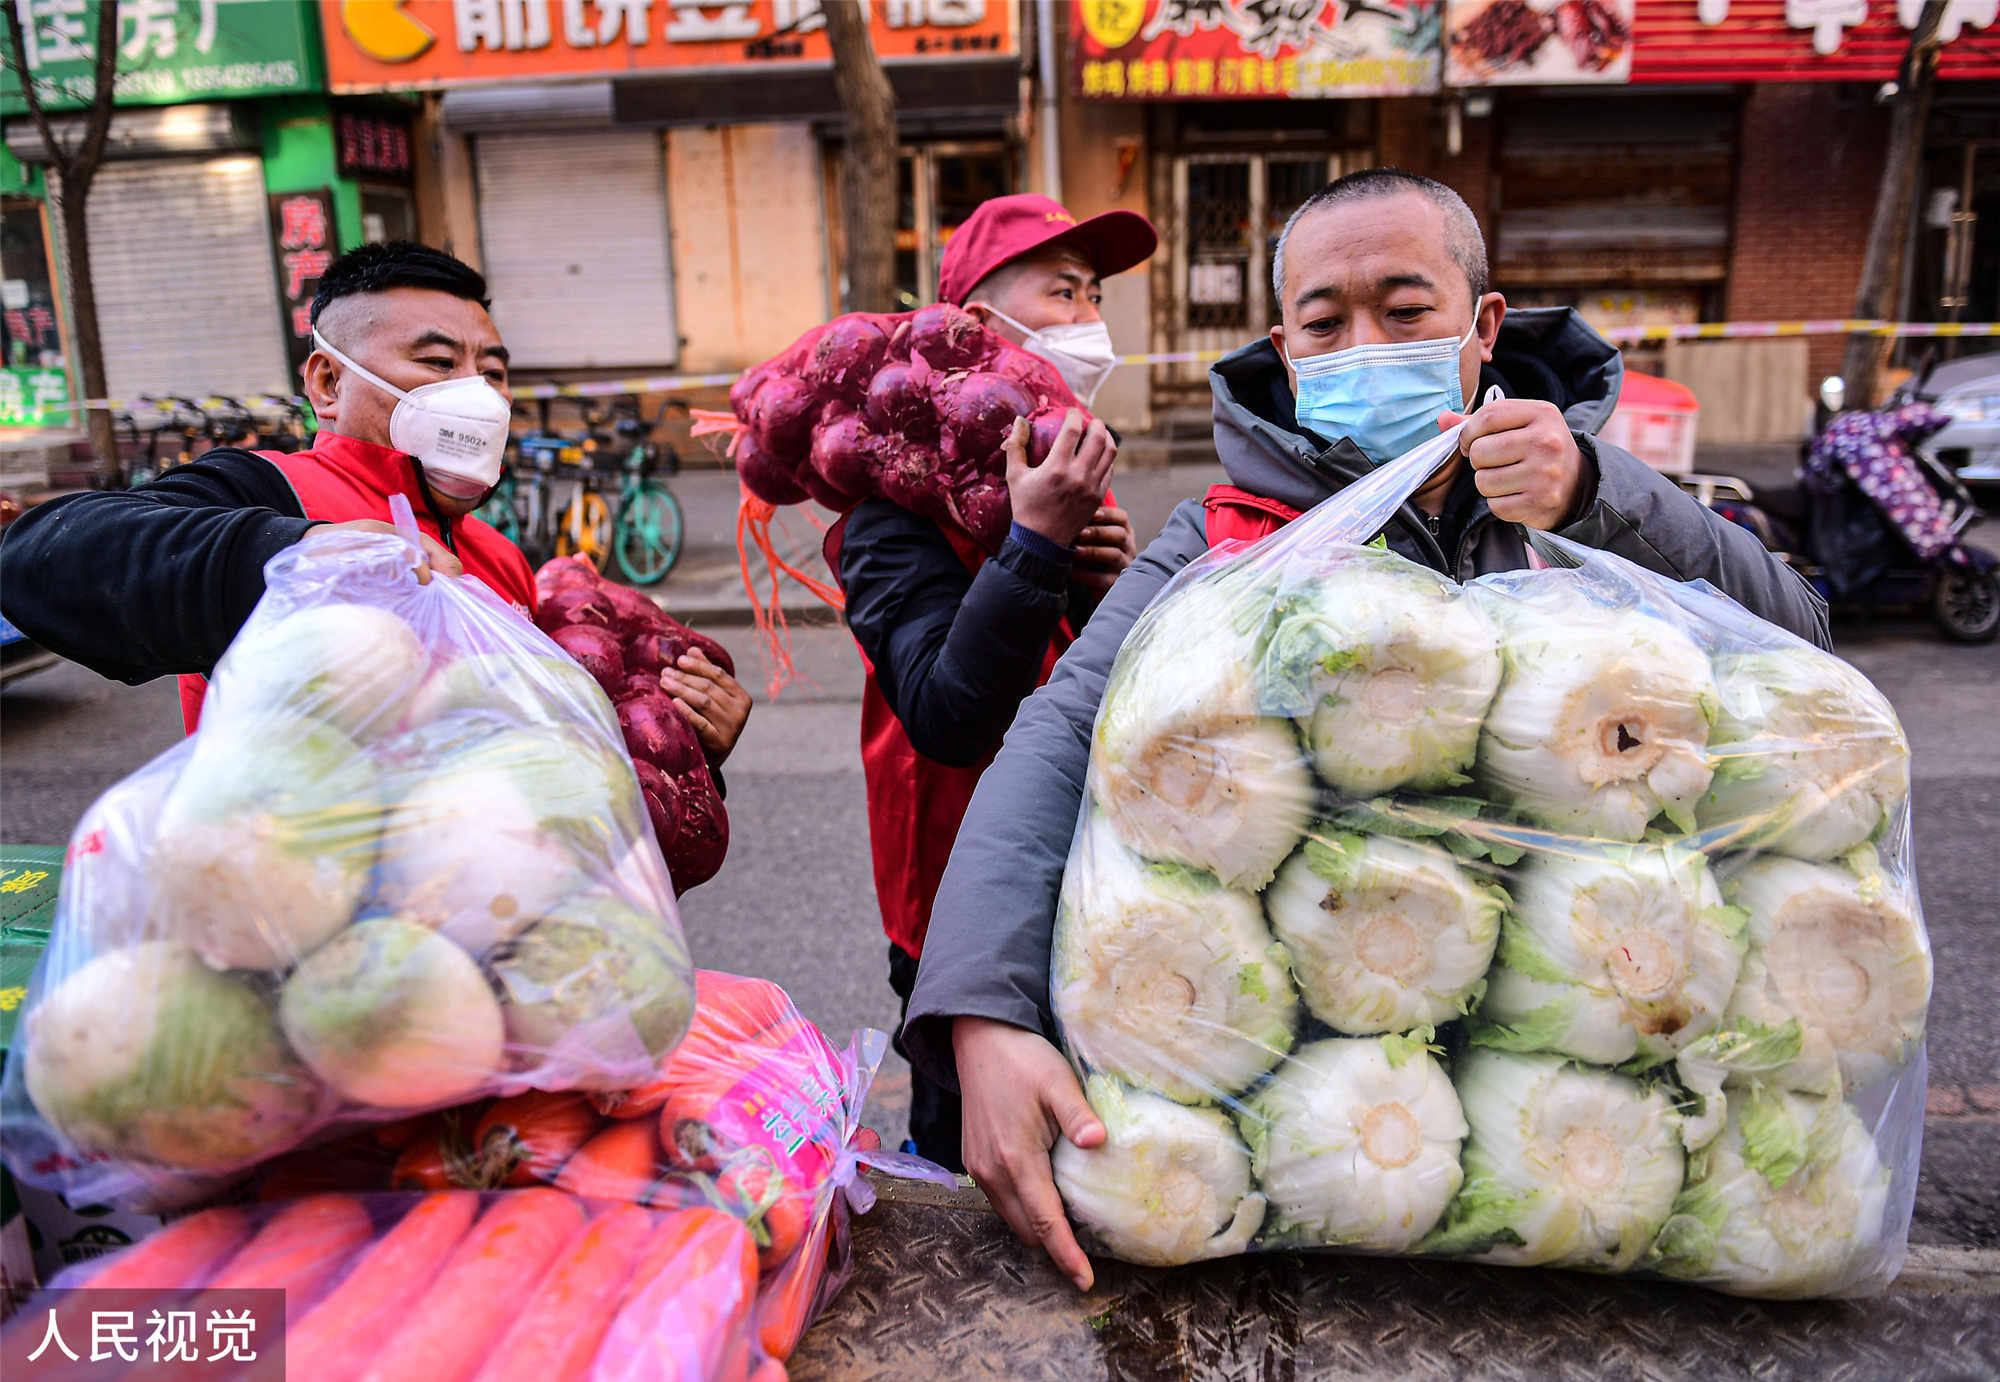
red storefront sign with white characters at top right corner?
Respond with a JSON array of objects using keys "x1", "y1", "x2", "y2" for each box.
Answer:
[{"x1": 1630, "y1": 0, "x2": 2000, "y2": 82}]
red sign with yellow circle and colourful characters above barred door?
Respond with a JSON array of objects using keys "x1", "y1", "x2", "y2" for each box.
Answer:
[{"x1": 1070, "y1": 0, "x2": 1442, "y2": 100}]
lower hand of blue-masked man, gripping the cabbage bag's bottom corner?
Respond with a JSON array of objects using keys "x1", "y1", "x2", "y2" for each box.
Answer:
[{"x1": 952, "y1": 1018, "x2": 1104, "y2": 1290}]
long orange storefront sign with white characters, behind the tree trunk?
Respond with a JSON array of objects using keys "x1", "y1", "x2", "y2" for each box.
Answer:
[{"x1": 320, "y1": 0, "x2": 1016, "y2": 92}]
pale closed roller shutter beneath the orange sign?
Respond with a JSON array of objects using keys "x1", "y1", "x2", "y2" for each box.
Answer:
[{"x1": 474, "y1": 130, "x2": 680, "y2": 370}]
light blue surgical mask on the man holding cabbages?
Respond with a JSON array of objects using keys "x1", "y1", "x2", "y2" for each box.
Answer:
[{"x1": 1286, "y1": 318, "x2": 1478, "y2": 466}]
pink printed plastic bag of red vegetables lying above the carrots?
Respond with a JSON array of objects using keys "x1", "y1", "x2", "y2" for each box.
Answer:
[{"x1": 258, "y1": 970, "x2": 954, "y2": 1358}]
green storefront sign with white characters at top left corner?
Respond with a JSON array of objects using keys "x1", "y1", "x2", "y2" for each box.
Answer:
[{"x1": 0, "y1": 0, "x2": 326, "y2": 114}]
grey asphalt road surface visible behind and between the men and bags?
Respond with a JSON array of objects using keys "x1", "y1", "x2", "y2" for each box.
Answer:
[{"x1": 0, "y1": 520, "x2": 2000, "y2": 1246}]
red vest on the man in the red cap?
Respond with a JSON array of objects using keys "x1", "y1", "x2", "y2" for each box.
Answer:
[{"x1": 824, "y1": 518, "x2": 1074, "y2": 956}]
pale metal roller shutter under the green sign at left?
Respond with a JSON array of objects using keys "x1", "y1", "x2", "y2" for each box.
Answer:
[{"x1": 50, "y1": 154, "x2": 292, "y2": 400}]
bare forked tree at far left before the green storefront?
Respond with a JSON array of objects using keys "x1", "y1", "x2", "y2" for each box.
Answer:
[{"x1": 0, "y1": 0, "x2": 124, "y2": 484}]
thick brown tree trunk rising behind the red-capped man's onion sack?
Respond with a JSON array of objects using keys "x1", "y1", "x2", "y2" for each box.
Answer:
[{"x1": 824, "y1": 0, "x2": 896, "y2": 312}]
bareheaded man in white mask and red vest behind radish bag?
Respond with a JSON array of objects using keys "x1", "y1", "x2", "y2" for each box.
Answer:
[{"x1": 0, "y1": 242, "x2": 750, "y2": 762}]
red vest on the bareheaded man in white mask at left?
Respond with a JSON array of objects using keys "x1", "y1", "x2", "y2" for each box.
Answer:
[{"x1": 180, "y1": 432, "x2": 534, "y2": 734}]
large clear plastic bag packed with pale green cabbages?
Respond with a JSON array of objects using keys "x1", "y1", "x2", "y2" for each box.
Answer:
[{"x1": 1050, "y1": 434, "x2": 1930, "y2": 1296}]
